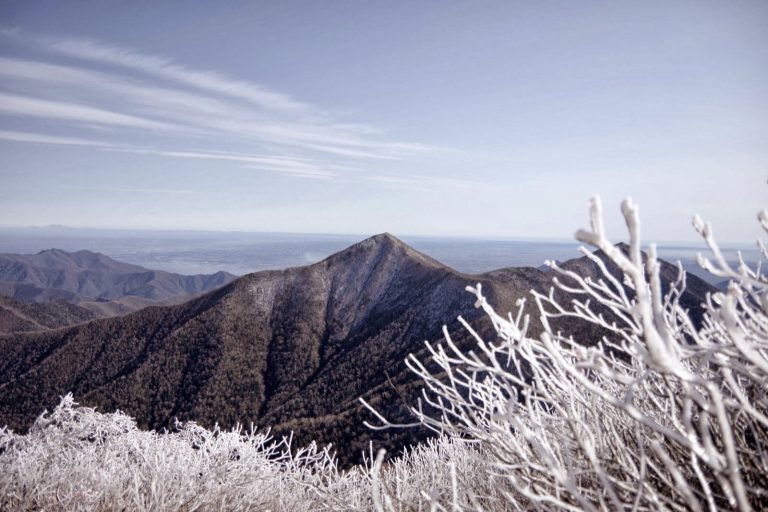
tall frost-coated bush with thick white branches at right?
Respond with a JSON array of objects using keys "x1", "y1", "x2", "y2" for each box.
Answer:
[{"x1": 366, "y1": 195, "x2": 768, "y2": 510}]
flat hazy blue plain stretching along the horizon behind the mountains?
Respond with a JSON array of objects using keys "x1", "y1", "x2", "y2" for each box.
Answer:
[{"x1": 0, "y1": 226, "x2": 758, "y2": 284}]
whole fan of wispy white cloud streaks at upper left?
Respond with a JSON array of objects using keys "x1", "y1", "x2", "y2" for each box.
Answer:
[{"x1": 0, "y1": 31, "x2": 452, "y2": 185}]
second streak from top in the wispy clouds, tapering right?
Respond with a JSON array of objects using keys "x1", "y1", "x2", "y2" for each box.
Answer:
[{"x1": 0, "y1": 52, "x2": 436, "y2": 160}]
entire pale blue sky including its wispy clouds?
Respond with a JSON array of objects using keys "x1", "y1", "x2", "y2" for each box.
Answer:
[{"x1": 0, "y1": 0, "x2": 768, "y2": 242}]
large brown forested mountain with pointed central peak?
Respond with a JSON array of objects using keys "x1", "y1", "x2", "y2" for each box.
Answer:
[{"x1": 0, "y1": 234, "x2": 711, "y2": 462}]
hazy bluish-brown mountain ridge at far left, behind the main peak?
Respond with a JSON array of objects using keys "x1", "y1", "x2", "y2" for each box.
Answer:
[{"x1": 0, "y1": 249, "x2": 235, "y2": 316}]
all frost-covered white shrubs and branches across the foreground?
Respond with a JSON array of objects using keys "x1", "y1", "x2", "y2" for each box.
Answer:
[{"x1": 0, "y1": 195, "x2": 768, "y2": 511}]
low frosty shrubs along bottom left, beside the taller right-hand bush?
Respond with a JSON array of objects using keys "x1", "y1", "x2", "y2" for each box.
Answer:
[{"x1": 0, "y1": 395, "x2": 504, "y2": 512}]
